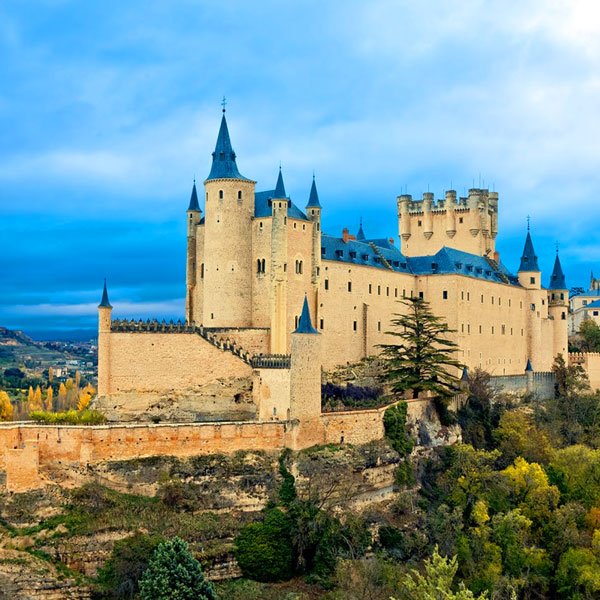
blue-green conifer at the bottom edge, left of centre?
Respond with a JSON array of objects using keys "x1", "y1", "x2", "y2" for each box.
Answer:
[{"x1": 140, "y1": 537, "x2": 217, "y2": 600}]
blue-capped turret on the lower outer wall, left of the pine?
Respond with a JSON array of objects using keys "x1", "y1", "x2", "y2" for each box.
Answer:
[{"x1": 290, "y1": 297, "x2": 321, "y2": 425}]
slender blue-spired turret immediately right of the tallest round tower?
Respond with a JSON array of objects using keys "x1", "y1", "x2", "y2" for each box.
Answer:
[{"x1": 270, "y1": 167, "x2": 289, "y2": 354}]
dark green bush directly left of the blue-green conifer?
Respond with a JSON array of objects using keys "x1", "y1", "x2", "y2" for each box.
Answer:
[{"x1": 97, "y1": 533, "x2": 164, "y2": 598}]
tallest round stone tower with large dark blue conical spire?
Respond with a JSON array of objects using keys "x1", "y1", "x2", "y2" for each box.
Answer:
[{"x1": 203, "y1": 109, "x2": 256, "y2": 327}]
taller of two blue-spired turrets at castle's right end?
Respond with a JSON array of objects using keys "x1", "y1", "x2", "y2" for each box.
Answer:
[{"x1": 517, "y1": 225, "x2": 543, "y2": 369}]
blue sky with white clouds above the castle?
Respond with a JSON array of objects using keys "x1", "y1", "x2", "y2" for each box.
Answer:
[{"x1": 0, "y1": 0, "x2": 600, "y2": 337}]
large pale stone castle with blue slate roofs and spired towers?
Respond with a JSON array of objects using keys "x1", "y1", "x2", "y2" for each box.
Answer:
[{"x1": 98, "y1": 112, "x2": 569, "y2": 417}]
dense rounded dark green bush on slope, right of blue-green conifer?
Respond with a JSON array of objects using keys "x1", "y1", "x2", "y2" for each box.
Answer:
[{"x1": 235, "y1": 508, "x2": 294, "y2": 582}]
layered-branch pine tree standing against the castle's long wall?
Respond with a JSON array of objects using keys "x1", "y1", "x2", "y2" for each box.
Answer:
[{"x1": 380, "y1": 298, "x2": 463, "y2": 405}]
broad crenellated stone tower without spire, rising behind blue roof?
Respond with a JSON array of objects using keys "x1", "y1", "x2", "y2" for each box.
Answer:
[{"x1": 397, "y1": 188, "x2": 498, "y2": 258}]
